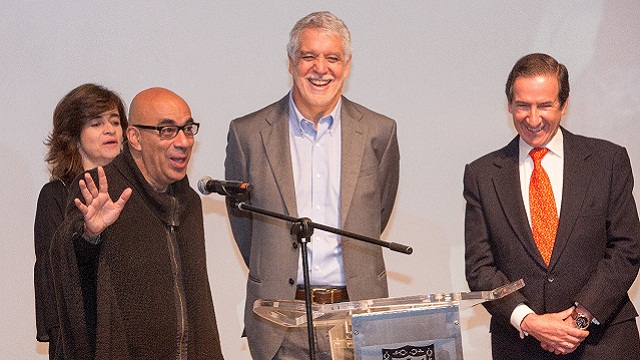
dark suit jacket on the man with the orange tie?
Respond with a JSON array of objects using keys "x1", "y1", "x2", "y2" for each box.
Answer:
[{"x1": 464, "y1": 129, "x2": 640, "y2": 358}]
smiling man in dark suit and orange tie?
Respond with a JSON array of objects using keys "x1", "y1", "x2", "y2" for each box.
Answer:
[{"x1": 464, "y1": 54, "x2": 640, "y2": 359}]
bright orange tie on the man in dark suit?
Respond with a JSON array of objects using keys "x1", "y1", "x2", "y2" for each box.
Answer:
[{"x1": 529, "y1": 148, "x2": 558, "y2": 266}]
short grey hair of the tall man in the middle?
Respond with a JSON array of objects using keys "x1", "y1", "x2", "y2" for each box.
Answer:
[{"x1": 287, "y1": 11, "x2": 352, "y2": 60}]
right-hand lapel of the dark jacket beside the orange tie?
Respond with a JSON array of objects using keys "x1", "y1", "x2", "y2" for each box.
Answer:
[{"x1": 549, "y1": 129, "x2": 592, "y2": 267}]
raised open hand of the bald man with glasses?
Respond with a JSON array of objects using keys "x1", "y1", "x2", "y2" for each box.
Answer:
[{"x1": 74, "y1": 166, "x2": 132, "y2": 238}]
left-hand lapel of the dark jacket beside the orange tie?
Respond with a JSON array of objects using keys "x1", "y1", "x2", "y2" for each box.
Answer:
[{"x1": 493, "y1": 136, "x2": 546, "y2": 267}]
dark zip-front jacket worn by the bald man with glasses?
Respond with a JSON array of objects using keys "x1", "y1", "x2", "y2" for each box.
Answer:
[{"x1": 51, "y1": 149, "x2": 222, "y2": 359}]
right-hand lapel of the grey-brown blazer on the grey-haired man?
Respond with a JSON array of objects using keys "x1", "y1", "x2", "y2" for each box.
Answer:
[{"x1": 340, "y1": 97, "x2": 366, "y2": 227}]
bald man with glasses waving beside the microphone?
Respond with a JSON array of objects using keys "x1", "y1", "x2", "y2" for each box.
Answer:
[{"x1": 51, "y1": 88, "x2": 222, "y2": 359}]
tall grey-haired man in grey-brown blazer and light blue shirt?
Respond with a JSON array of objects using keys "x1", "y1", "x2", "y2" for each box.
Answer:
[{"x1": 225, "y1": 12, "x2": 400, "y2": 360}]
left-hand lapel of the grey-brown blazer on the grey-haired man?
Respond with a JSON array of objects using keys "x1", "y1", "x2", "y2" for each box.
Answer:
[{"x1": 260, "y1": 95, "x2": 298, "y2": 216}]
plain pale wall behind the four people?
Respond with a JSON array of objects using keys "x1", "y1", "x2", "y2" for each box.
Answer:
[{"x1": 0, "y1": 0, "x2": 640, "y2": 359}]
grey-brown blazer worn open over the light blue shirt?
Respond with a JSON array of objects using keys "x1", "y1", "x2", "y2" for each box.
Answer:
[{"x1": 225, "y1": 95, "x2": 400, "y2": 359}]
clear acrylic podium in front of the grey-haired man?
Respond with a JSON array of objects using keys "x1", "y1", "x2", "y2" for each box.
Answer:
[{"x1": 253, "y1": 280, "x2": 524, "y2": 360}]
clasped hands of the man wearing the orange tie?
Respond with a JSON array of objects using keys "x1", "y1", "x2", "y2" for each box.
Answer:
[{"x1": 520, "y1": 307, "x2": 589, "y2": 355}]
